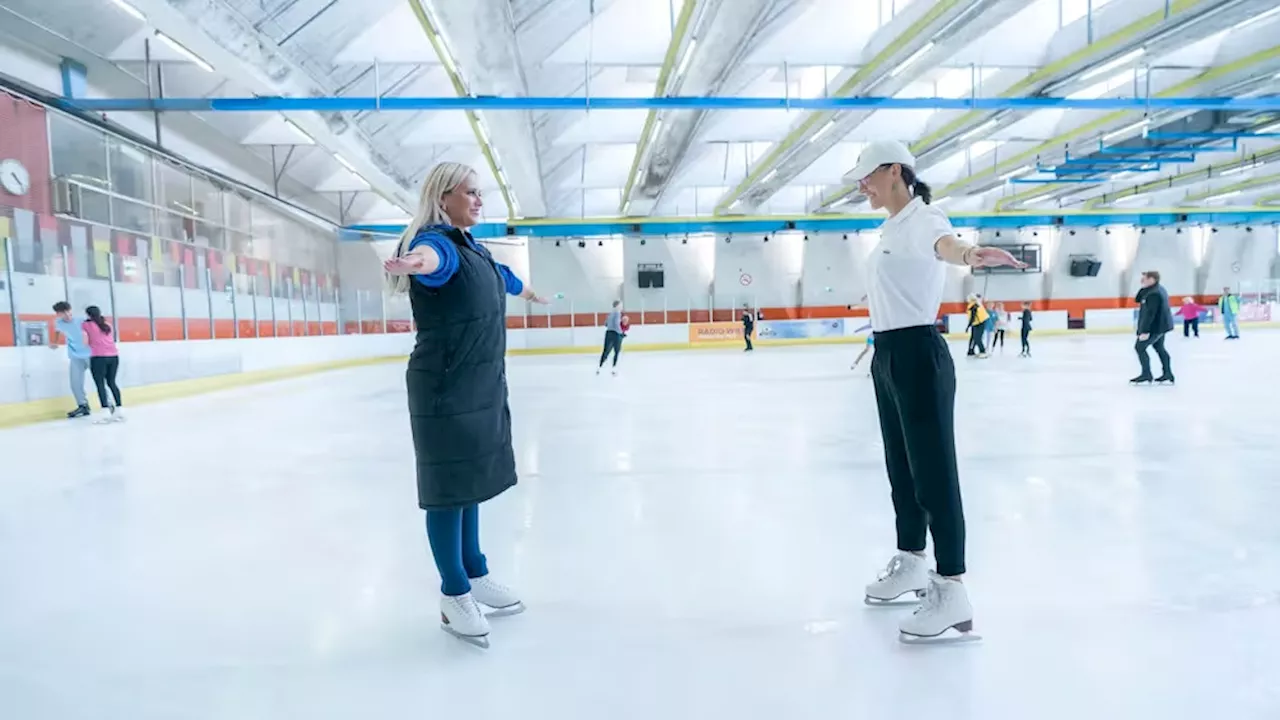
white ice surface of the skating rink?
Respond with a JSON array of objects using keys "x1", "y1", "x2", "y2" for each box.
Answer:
[{"x1": 0, "y1": 331, "x2": 1280, "y2": 720}]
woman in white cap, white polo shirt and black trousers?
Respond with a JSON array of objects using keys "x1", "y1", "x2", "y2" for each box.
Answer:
[{"x1": 845, "y1": 142, "x2": 1019, "y2": 642}]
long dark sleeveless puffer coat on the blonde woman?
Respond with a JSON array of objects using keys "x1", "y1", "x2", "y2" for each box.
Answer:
[{"x1": 406, "y1": 228, "x2": 516, "y2": 510}]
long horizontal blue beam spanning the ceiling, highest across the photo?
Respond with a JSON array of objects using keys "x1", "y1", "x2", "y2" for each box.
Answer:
[{"x1": 61, "y1": 95, "x2": 1280, "y2": 112}]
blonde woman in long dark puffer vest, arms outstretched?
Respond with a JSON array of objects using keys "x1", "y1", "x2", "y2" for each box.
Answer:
[{"x1": 384, "y1": 163, "x2": 547, "y2": 647}]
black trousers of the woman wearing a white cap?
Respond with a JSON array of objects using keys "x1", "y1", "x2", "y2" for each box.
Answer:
[{"x1": 872, "y1": 325, "x2": 962, "y2": 577}]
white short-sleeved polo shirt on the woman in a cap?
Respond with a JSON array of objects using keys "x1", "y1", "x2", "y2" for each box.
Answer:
[{"x1": 867, "y1": 197, "x2": 955, "y2": 332}]
